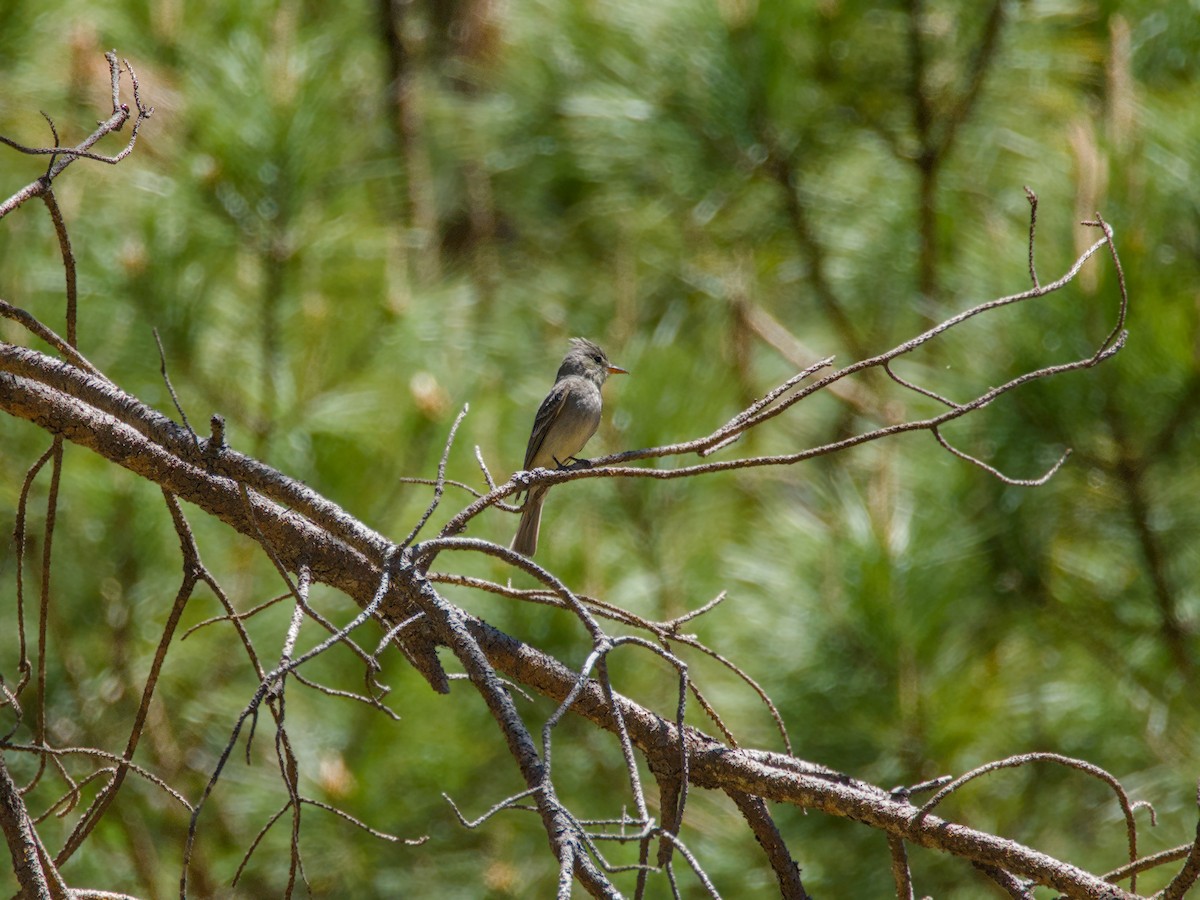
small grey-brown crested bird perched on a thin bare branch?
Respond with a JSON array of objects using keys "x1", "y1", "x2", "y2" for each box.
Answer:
[{"x1": 512, "y1": 337, "x2": 629, "y2": 557}]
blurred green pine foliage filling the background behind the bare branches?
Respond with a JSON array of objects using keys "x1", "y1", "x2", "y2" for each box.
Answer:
[{"x1": 0, "y1": 0, "x2": 1200, "y2": 898}]
